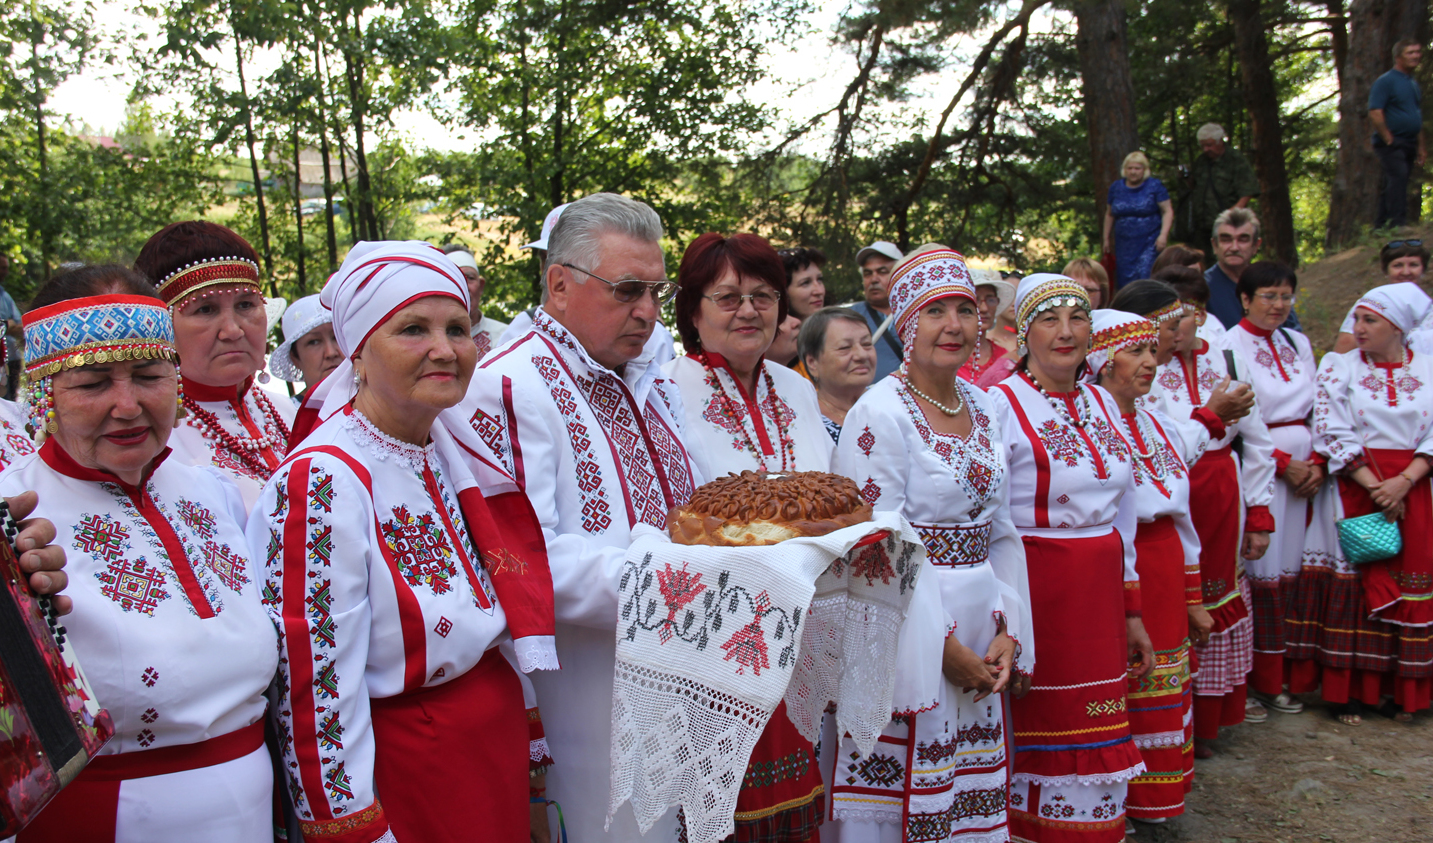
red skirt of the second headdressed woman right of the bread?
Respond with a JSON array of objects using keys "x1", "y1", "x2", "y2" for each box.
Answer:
[{"x1": 1012, "y1": 532, "x2": 1139, "y2": 778}]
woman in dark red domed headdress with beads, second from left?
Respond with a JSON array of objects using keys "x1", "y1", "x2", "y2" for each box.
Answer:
[{"x1": 135, "y1": 221, "x2": 294, "y2": 506}]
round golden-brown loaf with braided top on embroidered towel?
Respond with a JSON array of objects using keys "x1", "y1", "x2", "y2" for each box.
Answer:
[{"x1": 666, "y1": 472, "x2": 871, "y2": 548}]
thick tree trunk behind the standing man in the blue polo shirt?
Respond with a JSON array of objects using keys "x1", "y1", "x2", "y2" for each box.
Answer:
[{"x1": 1324, "y1": 0, "x2": 1427, "y2": 249}]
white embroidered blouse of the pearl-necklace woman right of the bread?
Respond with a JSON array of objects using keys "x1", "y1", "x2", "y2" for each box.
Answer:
[{"x1": 831, "y1": 374, "x2": 1035, "y2": 674}]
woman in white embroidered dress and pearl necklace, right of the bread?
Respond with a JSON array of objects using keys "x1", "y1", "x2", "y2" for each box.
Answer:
[{"x1": 827, "y1": 247, "x2": 1035, "y2": 843}]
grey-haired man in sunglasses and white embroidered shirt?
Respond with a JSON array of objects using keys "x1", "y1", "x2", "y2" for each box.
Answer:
[{"x1": 469, "y1": 194, "x2": 699, "y2": 843}]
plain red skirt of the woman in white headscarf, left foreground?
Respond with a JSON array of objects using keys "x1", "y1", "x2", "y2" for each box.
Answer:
[{"x1": 371, "y1": 647, "x2": 530, "y2": 843}]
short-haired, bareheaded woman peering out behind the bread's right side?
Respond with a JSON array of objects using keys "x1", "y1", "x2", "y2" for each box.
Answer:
[{"x1": 797, "y1": 307, "x2": 876, "y2": 442}]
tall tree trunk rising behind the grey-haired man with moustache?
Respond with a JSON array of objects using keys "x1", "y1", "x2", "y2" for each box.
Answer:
[{"x1": 1230, "y1": 0, "x2": 1298, "y2": 267}]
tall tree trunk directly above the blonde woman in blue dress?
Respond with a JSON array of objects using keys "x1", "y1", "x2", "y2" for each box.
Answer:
[{"x1": 1075, "y1": 0, "x2": 1139, "y2": 242}]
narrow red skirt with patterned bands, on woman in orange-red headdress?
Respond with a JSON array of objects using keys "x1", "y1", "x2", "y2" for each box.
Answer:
[{"x1": 1125, "y1": 518, "x2": 1194, "y2": 819}]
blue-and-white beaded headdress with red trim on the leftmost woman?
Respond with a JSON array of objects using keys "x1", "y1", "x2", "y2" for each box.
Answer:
[{"x1": 21, "y1": 295, "x2": 179, "y2": 440}]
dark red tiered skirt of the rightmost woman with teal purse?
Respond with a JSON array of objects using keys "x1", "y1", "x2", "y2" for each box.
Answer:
[{"x1": 1290, "y1": 449, "x2": 1433, "y2": 711}]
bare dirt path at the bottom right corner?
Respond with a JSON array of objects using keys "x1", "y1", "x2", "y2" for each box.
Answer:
[{"x1": 1131, "y1": 694, "x2": 1433, "y2": 843}]
